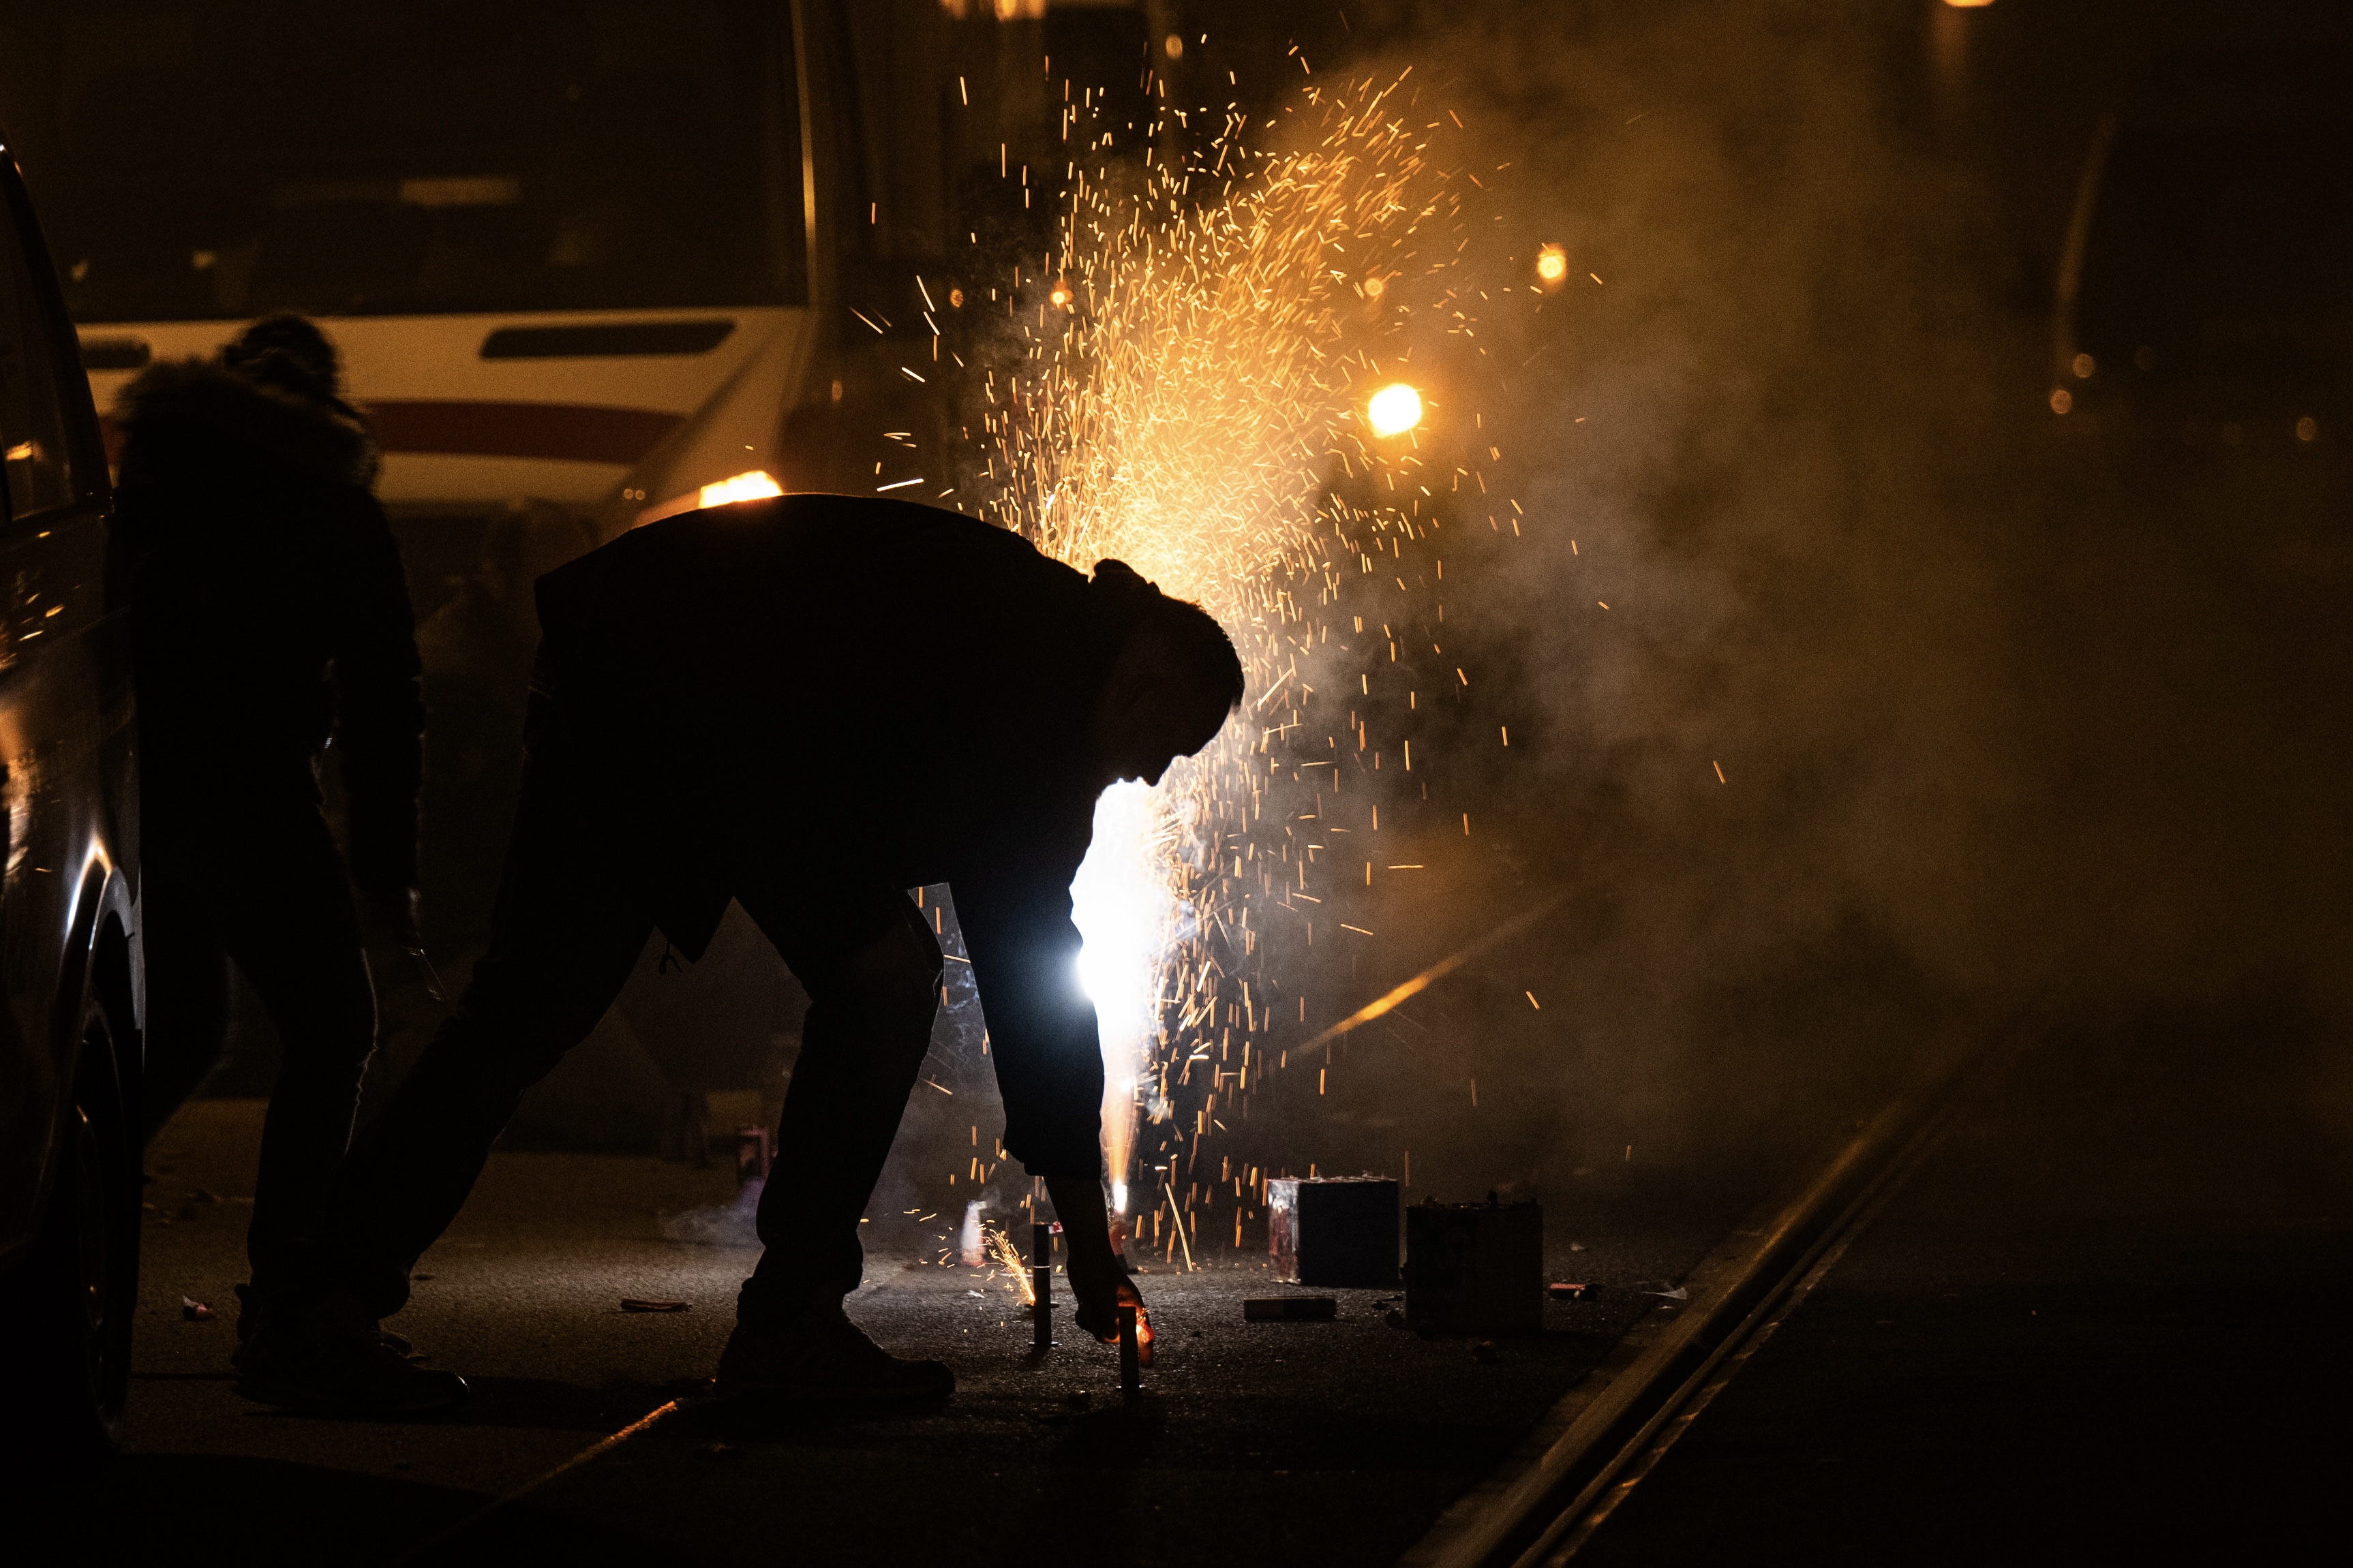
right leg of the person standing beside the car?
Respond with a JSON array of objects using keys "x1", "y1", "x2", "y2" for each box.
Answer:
[{"x1": 214, "y1": 809, "x2": 376, "y2": 1279}]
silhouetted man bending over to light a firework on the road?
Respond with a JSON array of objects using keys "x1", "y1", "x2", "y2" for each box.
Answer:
[{"x1": 240, "y1": 496, "x2": 1243, "y2": 1408}]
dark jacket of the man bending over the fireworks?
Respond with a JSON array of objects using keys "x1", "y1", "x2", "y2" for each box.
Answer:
[{"x1": 536, "y1": 496, "x2": 1155, "y2": 1175}]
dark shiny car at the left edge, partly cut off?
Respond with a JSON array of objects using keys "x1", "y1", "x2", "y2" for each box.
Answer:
[{"x1": 0, "y1": 136, "x2": 141, "y2": 1481}]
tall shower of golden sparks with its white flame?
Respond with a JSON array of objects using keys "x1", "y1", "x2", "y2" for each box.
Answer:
[{"x1": 950, "y1": 67, "x2": 1492, "y2": 1255}]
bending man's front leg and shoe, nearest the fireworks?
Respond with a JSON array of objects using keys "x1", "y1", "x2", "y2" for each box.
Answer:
[{"x1": 720, "y1": 884, "x2": 956, "y2": 1399}]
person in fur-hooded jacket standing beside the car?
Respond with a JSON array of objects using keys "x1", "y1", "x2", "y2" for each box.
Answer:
[{"x1": 113, "y1": 315, "x2": 423, "y2": 1338}]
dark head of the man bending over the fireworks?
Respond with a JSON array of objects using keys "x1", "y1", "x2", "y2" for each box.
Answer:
[{"x1": 1094, "y1": 562, "x2": 1243, "y2": 783}]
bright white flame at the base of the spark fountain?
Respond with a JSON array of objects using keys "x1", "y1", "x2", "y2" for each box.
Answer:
[{"x1": 1071, "y1": 780, "x2": 1176, "y2": 1213}]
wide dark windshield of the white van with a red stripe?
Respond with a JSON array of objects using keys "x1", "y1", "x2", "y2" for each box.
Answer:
[{"x1": 0, "y1": 0, "x2": 807, "y2": 322}]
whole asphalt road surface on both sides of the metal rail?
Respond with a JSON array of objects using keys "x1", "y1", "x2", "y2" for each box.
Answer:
[{"x1": 32, "y1": 1004, "x2": 2353, "y2": 1566}]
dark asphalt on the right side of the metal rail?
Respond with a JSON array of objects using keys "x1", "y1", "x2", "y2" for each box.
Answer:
[{"x1": 1574, "y1": 1009, "x2": 2353, "y2": 1568}]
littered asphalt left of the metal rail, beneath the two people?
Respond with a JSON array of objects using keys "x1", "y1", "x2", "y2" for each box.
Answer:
[{"x1": 22, "y1": 1100, "x2": 1753, "y2": 1563}]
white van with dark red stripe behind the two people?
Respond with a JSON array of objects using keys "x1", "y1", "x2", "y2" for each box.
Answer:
[{"x1": 0, "y1": 0, "x2": 1146, "y2": 536}]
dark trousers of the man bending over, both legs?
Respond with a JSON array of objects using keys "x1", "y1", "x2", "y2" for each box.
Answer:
[{"x1": 299, "y1": 694, "x2": 941, "y2": 1328}]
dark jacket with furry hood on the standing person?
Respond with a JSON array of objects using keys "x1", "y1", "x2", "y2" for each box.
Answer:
[{"x1": 115, "y1": 360, "x2": 423, "y2": 898}]
